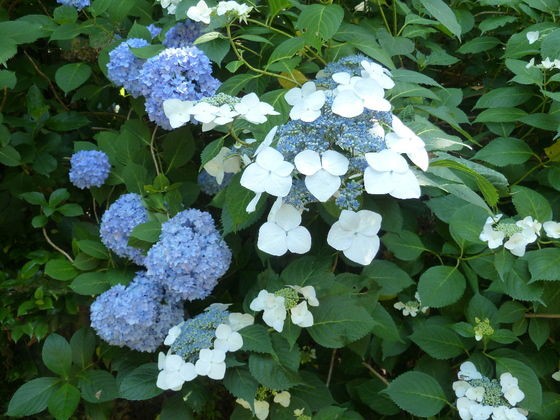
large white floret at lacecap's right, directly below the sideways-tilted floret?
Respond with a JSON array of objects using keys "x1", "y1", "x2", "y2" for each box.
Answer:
[{"x1": 364, "y1": 149, "x2": 421, "y2": 199}]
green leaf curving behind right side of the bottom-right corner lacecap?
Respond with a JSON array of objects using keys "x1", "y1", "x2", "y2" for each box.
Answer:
[{"x1": 495, "y1": 357, "x2": 542, "y2": 412}]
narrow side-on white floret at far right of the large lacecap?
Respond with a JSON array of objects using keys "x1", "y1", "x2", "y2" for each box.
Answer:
[{"x1": 385, "y1": 115, "x2": 429, "y2": 171}]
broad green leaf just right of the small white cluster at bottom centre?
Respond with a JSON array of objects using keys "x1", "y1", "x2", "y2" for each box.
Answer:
[{"x1": 307, "y1": 295, "x2": 375, "y2": 348}]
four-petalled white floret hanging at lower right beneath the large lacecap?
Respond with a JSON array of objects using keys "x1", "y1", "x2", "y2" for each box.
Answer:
[{"x1": 327, "y1": 210, "x2": 381, "y2": 265}]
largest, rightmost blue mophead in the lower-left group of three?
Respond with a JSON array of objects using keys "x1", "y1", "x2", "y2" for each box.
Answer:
[{"x1": 145, "y1": 209, "x2": 231, "y2": 301}]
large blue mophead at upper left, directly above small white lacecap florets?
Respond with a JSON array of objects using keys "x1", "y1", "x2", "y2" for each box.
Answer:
[{"x1": 139, "y1": 47, "x2": 220, "y2": 130}]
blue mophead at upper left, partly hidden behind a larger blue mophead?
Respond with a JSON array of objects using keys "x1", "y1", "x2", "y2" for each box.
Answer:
[{"x1": 107, "y1": 38, "x2": 149, "y2": 98}]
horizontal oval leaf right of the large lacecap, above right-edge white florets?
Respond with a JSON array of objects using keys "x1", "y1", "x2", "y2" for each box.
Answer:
[{"x1": 474, "y1": 137, "x2": 533, "y2": 167}]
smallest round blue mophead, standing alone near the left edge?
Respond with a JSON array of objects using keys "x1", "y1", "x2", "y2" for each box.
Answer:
[{"x1": 68, "y1": 150, "x2": 111, "y2": 190}]
